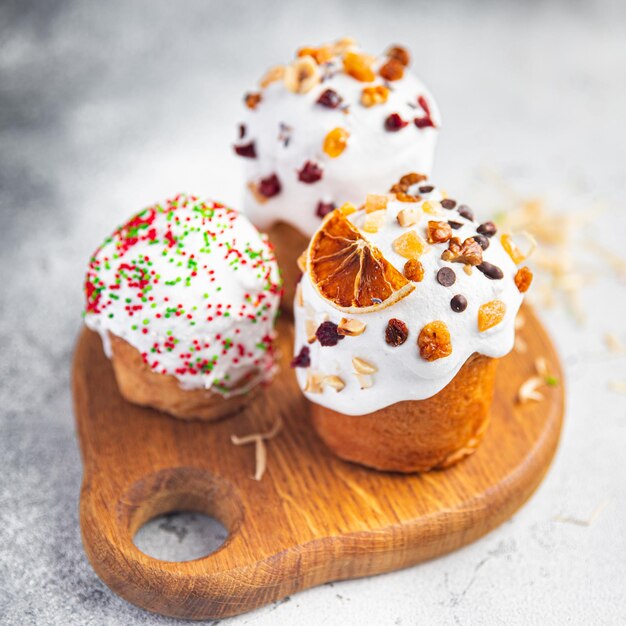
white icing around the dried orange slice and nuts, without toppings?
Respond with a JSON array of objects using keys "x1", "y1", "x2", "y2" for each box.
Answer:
[{"x1": 294, "y1": 181, "x2": 522, "y2": 415}]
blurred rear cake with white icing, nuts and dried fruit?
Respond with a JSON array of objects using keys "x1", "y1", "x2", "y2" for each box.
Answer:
[{"x1": 234, "y1": 39, "x2": 440, "y2": 307}]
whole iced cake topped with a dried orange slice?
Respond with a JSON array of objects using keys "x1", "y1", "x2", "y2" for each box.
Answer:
[{"x1": 292, "y1": 173, "x2": 532, "y2": 472}]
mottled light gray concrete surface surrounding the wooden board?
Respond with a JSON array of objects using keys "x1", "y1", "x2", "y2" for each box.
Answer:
[{"x1": 0, "y1": 0, "x2": 626, "y2": 626}]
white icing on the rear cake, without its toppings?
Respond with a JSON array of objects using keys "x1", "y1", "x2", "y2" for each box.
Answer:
[{"x1": 238, "y1": 45, "x2": 440, "y2": 236}]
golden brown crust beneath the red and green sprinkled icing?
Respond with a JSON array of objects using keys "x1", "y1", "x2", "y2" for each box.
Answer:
[{"x1": 109, "y1": 333, "x2": 259, "y2": 421}]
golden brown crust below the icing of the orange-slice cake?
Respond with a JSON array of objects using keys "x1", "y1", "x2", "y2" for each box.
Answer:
[{"x1": 311, "y1": 355, "x2": 497, "y2": 472}]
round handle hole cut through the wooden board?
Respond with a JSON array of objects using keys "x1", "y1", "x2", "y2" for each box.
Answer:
[{"x1": 119, "y1": 468, "x2": 242, "y2": 562}]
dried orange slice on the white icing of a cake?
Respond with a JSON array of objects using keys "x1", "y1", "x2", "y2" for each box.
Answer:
[{"x1": 307, "y1": 211, "x2": 415, "y2": 313}]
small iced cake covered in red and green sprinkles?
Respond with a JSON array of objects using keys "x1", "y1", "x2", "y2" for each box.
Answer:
[{"x1": 84, "y1": 195, "x2": 281, "y2": 420}]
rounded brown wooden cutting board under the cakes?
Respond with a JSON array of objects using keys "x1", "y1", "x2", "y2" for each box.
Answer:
[{"x1": 73, "y1": 307, "x2": 564, "y2": 619}]
